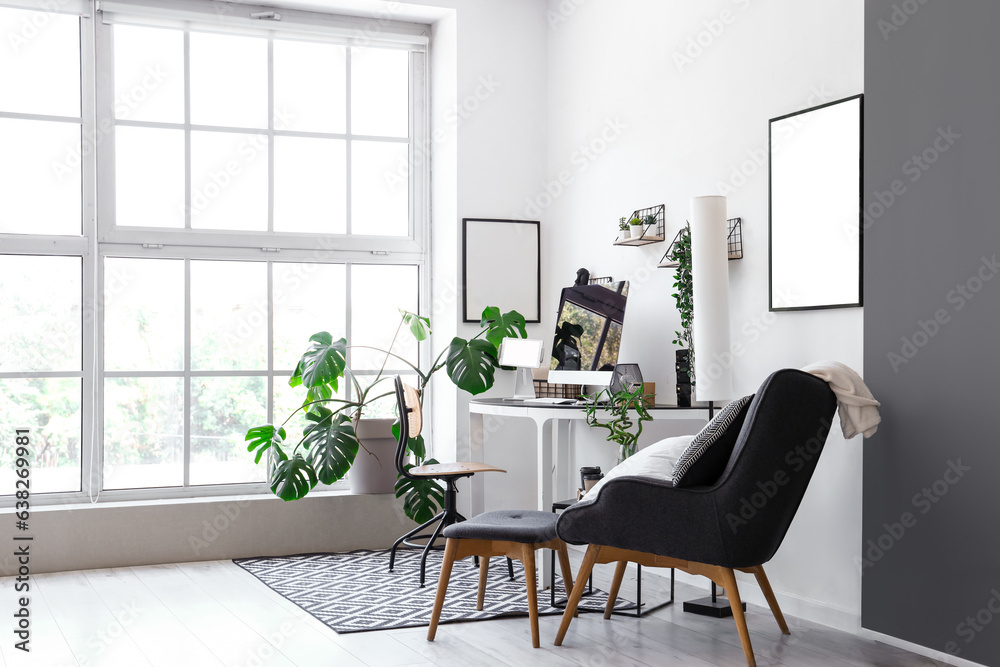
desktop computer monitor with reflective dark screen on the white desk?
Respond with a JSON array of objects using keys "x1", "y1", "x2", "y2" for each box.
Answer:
[{"x1": 548, "y1": 281, "x2": 628, "y2": 385}]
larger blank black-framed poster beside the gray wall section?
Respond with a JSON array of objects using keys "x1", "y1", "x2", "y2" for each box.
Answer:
[{"x1": 768, "y1": 95, "x2": 864, "y2": 311}]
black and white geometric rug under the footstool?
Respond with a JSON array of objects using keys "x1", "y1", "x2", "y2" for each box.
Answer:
[{"x1": 233, "y1": 549, "x2": 635, "y2": 633}]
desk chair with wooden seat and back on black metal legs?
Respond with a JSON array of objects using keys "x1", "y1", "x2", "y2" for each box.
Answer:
[{"x1": 389, "y1": 376, "x2": 514, "y2": 588}]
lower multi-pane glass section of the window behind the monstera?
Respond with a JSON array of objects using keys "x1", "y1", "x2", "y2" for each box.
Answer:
[{"x1": 102, "y1": 256, "x2": 419, "y2": 490}]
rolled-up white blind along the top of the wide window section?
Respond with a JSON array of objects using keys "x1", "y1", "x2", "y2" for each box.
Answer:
[{"x1": 98, "y1": 0, "x2": 430, "y2": 51}]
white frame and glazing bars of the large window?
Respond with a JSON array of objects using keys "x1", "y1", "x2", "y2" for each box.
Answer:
[{"x1": 0, "y1": 0, "x2": 430, "y2": 506}]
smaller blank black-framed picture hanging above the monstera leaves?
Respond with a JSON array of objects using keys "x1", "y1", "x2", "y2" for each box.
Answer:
[{"x1": 462, "y1": 218, "x2": 542, "y2": 323}]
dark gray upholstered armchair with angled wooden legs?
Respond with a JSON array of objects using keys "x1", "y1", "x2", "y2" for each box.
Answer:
[{"x1": 556, "y1": 369, "x2": 837, "y2": 665}]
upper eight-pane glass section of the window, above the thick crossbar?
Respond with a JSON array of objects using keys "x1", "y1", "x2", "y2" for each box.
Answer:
[{"x1": 114, "y1": 25, "x2": 413, "y2": 243}]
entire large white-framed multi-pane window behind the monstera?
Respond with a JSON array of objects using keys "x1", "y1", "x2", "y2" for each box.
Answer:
[{"x1": 0, "y1": 2, "x2": 428, "y2": 499}]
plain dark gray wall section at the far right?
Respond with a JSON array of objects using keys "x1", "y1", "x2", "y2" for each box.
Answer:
[{"x1": 859, "y1": 0, "x2": 1000, "y2": 665}]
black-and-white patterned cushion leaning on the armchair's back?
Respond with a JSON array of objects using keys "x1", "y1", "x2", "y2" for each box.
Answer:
[{"x1": 673, "y1": 394, "x2": 753, "y2": 487}]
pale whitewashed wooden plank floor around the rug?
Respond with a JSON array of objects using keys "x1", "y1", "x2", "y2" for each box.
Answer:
[{"x1": 0, "y1": 558, "x2": 938, "y2": 667}]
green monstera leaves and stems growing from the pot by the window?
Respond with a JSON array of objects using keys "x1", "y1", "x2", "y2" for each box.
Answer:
[{"x1": 246, "y1": 307, "x2": 527, "y2": 523}]
